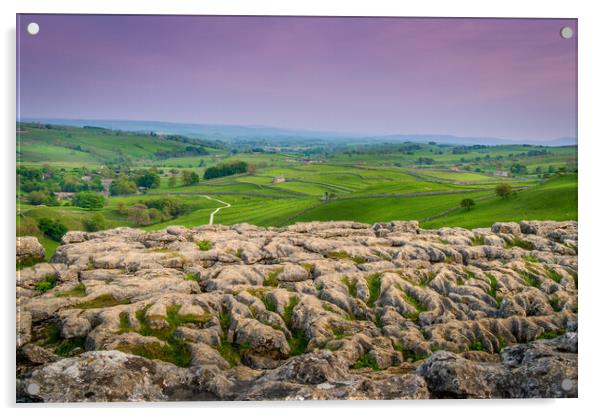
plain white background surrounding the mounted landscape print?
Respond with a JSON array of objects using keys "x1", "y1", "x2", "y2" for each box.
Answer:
[{"x1": 0, "y1": 0, "x2": 602, "y2": 416}]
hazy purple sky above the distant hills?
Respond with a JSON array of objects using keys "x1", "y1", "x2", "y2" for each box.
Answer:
[{"x1": 17, "y1": 15, "x2": 577, "y2": 140}]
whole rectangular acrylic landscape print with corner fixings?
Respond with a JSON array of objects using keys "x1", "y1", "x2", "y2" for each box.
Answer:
[{"x1": 16, "y1": 15, "x2": 578, "y2": 402}]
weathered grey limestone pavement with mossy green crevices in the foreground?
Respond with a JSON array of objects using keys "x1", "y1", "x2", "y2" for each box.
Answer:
[{"x1": 17, "y1": 221, "x2": 578, "y2": 402}]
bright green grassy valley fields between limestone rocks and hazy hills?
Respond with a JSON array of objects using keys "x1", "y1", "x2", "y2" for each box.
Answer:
[{"x1": 17, "y1": 124, "x2": 577, "y2": 253}]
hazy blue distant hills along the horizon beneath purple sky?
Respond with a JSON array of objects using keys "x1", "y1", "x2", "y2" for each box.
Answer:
[{"x1": 21, "y1": 118, "x2": 577, "y2": 146}]
